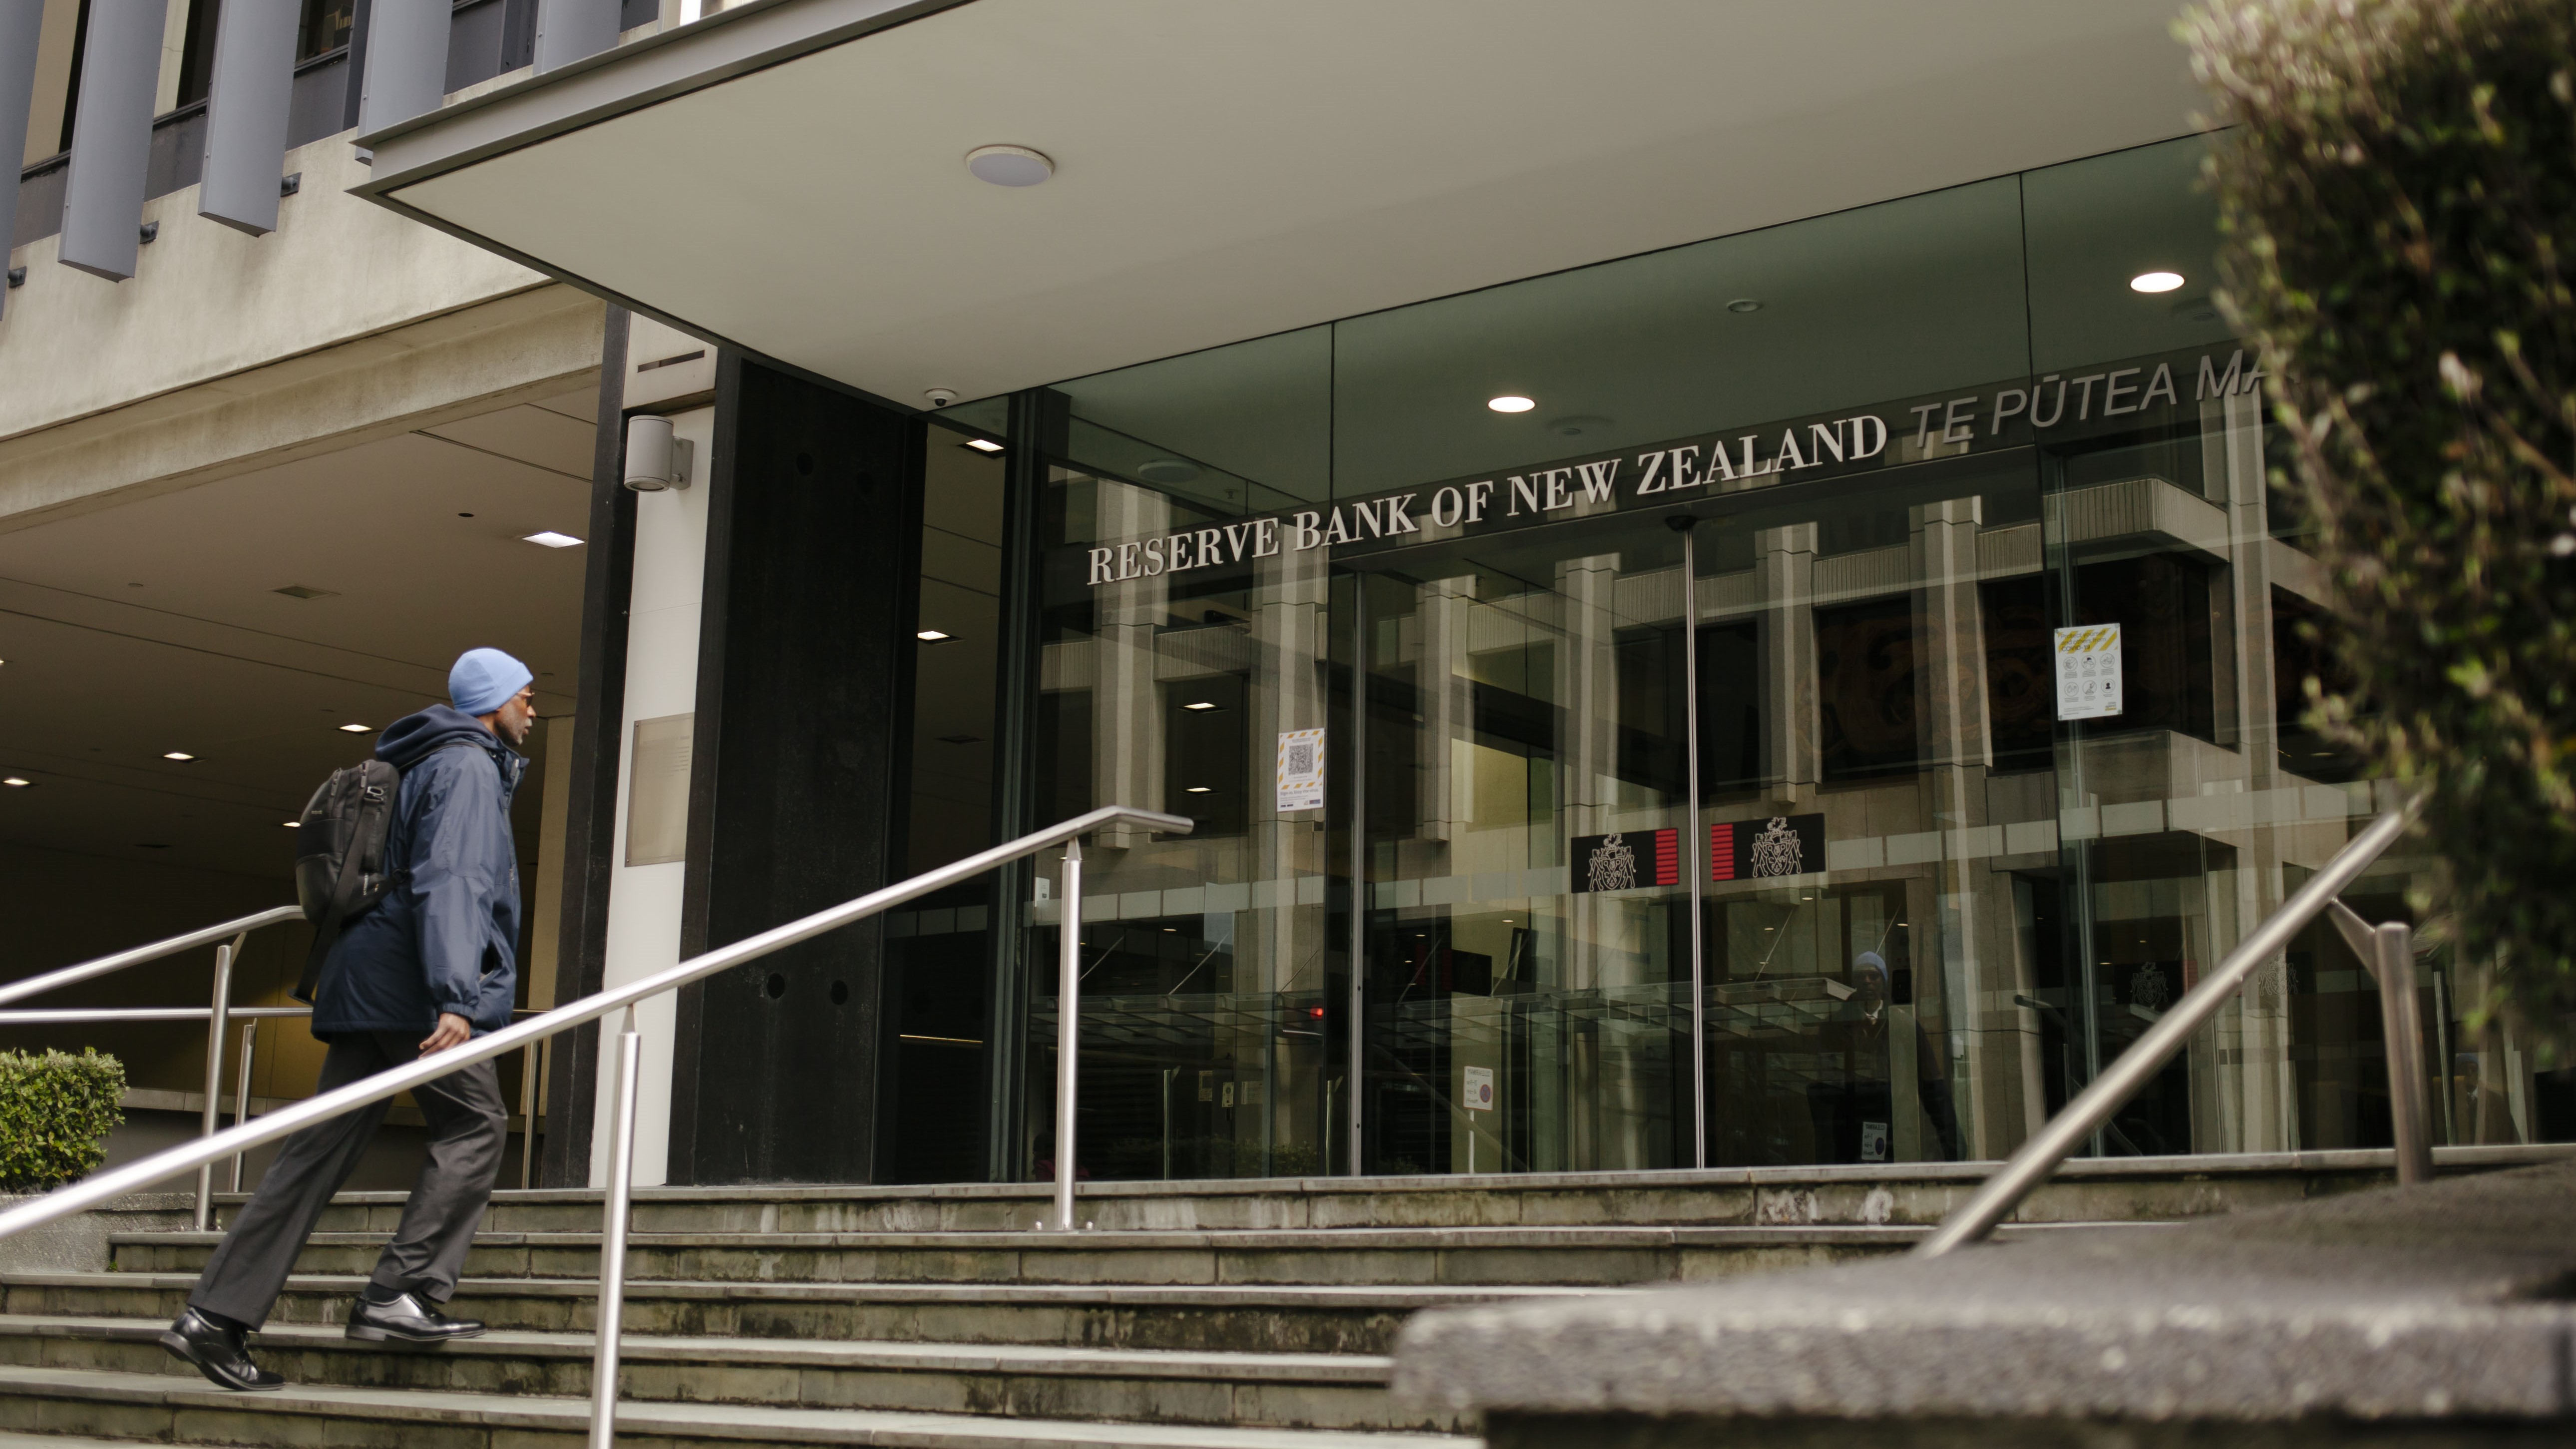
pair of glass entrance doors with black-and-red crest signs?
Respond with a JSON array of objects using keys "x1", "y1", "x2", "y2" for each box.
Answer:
[{"x1": 1355, "y1": 455, "x2": 2058, "y2": 1173}]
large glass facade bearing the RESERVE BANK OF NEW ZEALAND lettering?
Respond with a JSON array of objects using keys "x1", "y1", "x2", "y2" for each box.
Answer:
[{"x1": 953, "y1": 139, "x2": 2569, "y2": 1179}]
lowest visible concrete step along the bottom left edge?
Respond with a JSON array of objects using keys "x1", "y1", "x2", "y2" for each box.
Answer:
[{"x1": 0, "y1": 1367, "x2": 1473, "y2": 1449}]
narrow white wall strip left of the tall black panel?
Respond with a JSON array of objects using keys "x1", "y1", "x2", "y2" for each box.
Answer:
[{"x1": 590, "y1": 406, "x2": 716, "y2": 1186}]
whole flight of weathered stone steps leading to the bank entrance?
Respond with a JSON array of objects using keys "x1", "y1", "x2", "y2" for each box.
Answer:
[{"x1": 0, "y1": 1153, "x2": 2522, "y2": 1449}]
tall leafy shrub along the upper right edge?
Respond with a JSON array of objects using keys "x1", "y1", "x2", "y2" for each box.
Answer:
[{"x1": 2182, "y1": 0, "x2": 2576, "y2": 1045}]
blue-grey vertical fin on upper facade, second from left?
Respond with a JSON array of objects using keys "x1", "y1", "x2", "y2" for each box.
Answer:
[{"x1": 56, "y1": 0, "x2": 165, "y2": 281}]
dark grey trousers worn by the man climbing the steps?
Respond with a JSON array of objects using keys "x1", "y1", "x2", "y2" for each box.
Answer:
[{"x1": 188, "y1": 1032, "x2": 510, "y2": 1328}]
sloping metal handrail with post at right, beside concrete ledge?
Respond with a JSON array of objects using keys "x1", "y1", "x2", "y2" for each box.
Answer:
[{"x1": 1914, "y1": 805, "x2": 2432, "y2": 1259}]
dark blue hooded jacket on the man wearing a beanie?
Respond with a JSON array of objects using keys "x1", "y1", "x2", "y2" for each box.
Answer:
[{"x1": 312, "y1": 705, "x2": 528, "y2": 1040}]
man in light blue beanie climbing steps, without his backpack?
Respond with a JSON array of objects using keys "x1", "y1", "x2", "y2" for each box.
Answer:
[{"x1": 160, "y1": 649, "x2": 536, "y2": 1390}]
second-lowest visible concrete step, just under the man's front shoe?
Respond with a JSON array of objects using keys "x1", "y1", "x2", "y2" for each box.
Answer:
[{"x1": 0, "y1": 1315, "x2": 1458, "y2": 1431}]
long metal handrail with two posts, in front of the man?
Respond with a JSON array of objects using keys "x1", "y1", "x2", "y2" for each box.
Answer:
[{"x1": 0, "y1": 805, "x2": 1193, "y2": 1449}]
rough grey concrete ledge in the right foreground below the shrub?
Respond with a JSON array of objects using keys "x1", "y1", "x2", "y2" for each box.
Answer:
[{"x1": 1396, "y1": 1163, "x2": 2576, "y2": 1449}]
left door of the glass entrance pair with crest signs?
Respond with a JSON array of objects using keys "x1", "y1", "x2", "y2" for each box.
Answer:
[{"x1": 1360, "y1": 520, "x2": 1690, "y2": 1173}]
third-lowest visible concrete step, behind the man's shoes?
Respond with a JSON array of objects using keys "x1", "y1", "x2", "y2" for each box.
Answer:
[{"x1": 0, "y1": 1271, "x2": 1625, "y2": 1354}]
